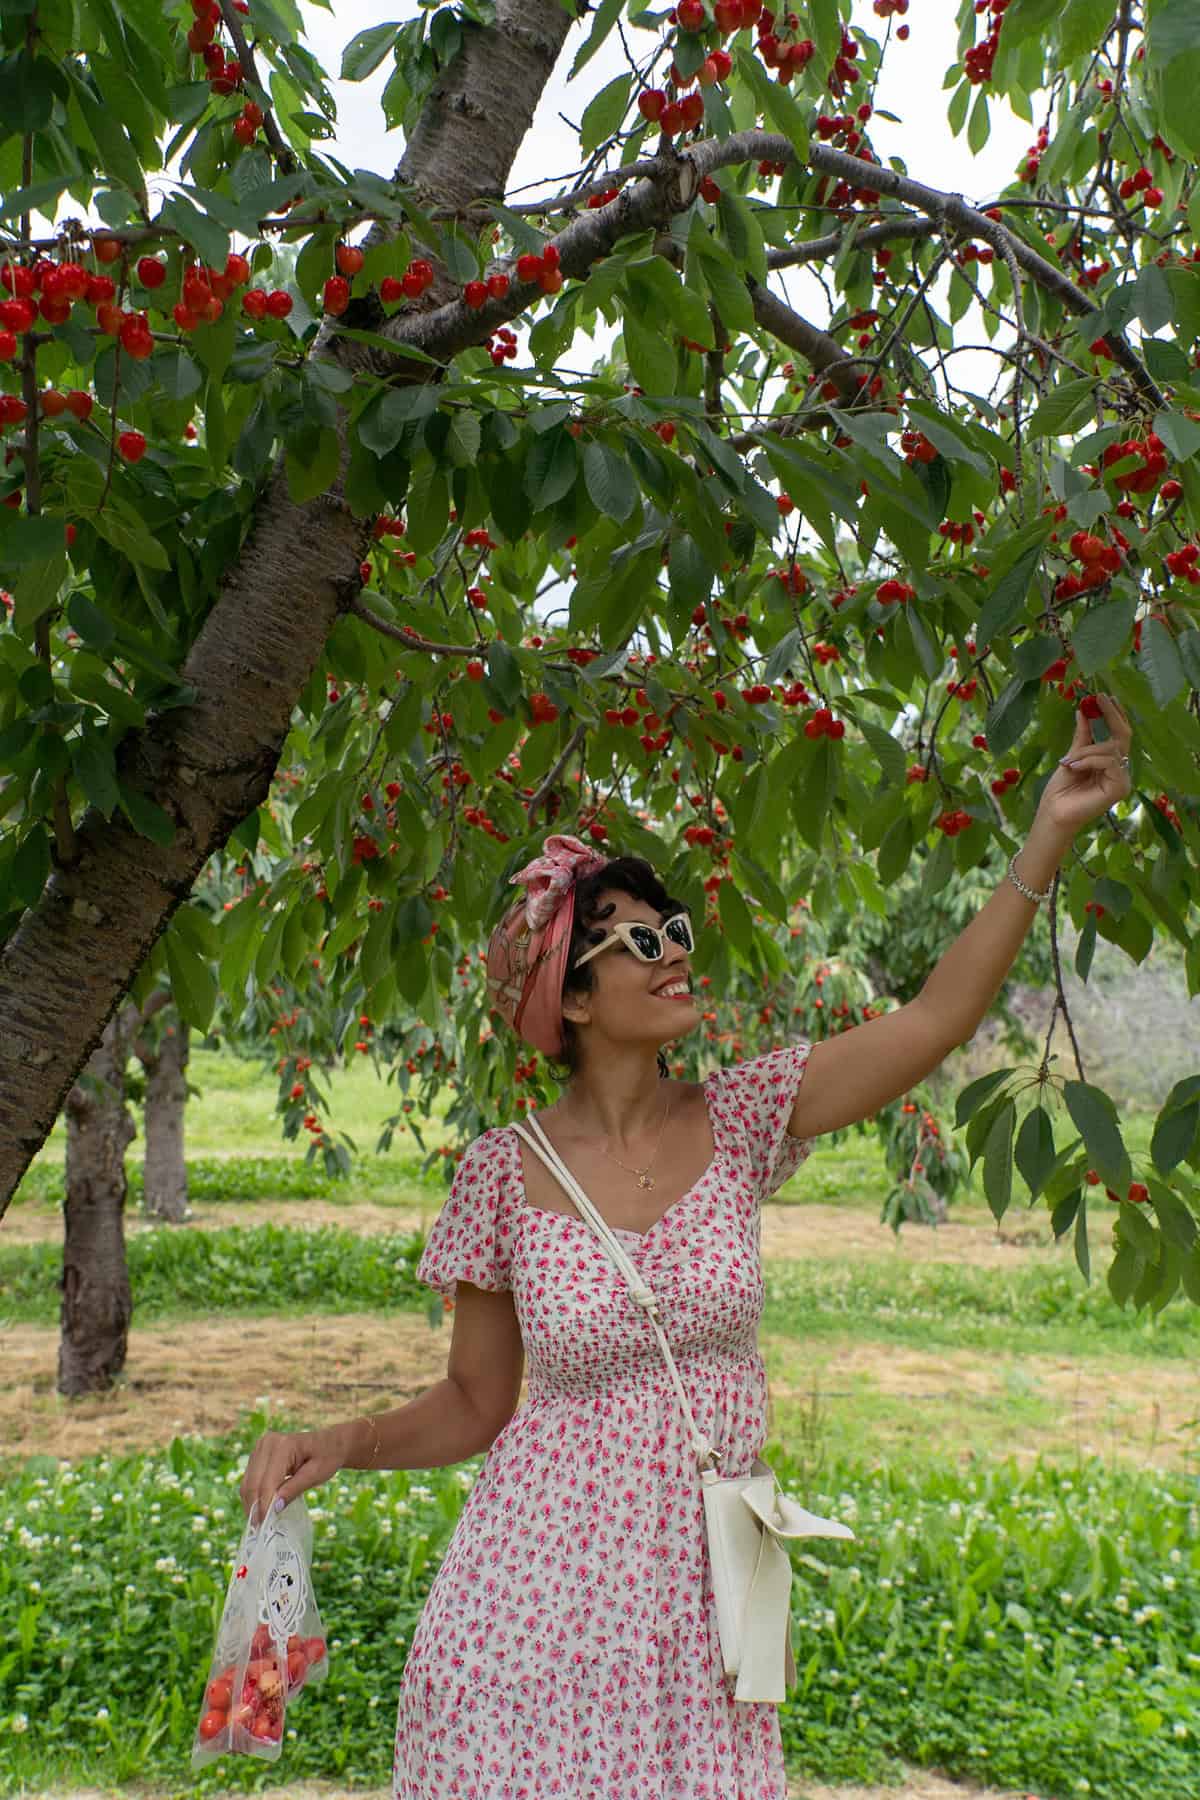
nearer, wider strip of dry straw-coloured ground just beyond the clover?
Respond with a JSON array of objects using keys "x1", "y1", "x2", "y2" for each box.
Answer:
[{"x1": 0, "y1": 1312, "x2": 1196, "y2": 1467}]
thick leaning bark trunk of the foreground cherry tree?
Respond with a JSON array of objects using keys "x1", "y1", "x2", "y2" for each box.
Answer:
[{"x1": 0, "y1": 0, "x2": 574, "y2": 1217}]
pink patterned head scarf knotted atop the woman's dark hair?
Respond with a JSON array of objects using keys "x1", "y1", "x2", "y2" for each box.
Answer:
[{"x1": 488, "y1": 833, "x2": 610, "y2": 1057}]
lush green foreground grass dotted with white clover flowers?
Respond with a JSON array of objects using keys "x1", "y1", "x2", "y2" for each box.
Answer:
[{"x1": 0, "y1": 1413, "x2": 1200, "y2": 1800}]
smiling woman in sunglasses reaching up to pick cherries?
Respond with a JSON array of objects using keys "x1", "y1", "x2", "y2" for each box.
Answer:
[{"x1": 241, "y1": 698, "x2": 1130, "y2": 1800}]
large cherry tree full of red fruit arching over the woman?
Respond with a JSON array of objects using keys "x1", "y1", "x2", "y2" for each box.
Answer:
[{"x1": 0, "y1": 0, "x2": 1200, "y2": 1305}]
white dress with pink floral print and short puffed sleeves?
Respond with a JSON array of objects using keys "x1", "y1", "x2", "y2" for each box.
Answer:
[{"x1": 394, "y1": 1042, "x2": 813, "y2": 1800}]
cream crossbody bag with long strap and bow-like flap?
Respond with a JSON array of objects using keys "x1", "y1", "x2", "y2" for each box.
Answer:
[{"x1": 513, "y1": 1114, "x2": 855, "y2": 1701}]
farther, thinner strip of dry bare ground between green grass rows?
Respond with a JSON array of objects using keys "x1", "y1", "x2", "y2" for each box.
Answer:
[{"x1": 0, "y1": 1197, "x2": 1110, "y2": 1269}]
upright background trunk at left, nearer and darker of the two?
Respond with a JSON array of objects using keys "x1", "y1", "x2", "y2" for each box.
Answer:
[{"x1": 58, "y1": 1006, "x2": 137, "y2": 1395}]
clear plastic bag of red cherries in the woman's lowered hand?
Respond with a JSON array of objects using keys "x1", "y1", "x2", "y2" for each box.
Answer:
[{"x1": 193, "y1": 1494, "x2": 329, "y2": 1769}]
